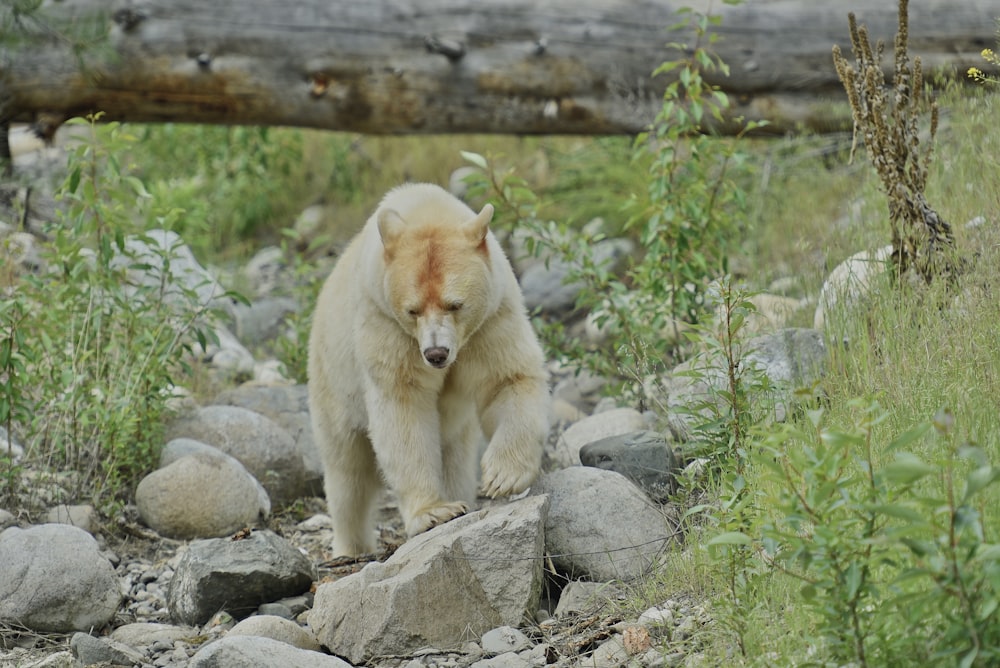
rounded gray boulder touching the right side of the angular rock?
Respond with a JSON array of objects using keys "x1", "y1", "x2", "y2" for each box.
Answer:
[{"x1": 531, "y1": 466, "x2": 676, "y2": 582}]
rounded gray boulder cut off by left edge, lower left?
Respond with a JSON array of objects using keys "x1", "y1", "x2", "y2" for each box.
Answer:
[{"x1": 0, "y1": 524, "x2": 122, "y2": 633}]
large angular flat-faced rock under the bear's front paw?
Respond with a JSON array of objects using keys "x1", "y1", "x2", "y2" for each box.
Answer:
[{"x1": 309, "y1": 496, "x2": 548, "y2": 663}]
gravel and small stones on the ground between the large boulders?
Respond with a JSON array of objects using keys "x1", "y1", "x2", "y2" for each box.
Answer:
[{"x1": 0, "y1": 486, "x2": 711, "y2": 668}]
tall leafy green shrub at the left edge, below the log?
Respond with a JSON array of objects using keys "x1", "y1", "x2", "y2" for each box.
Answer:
[{"x1": 0, "y1": 118, "x2": 226, "y2": 504}]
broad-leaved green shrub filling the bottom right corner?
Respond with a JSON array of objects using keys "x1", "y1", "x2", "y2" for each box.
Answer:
[{"x1": 744, "y1": 402, "x2": 1000, "y2": 666}]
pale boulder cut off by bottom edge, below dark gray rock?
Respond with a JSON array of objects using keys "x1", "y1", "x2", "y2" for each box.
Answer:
[{"x1": 188, "y1": 635, "x2": 351, "y2": 668}]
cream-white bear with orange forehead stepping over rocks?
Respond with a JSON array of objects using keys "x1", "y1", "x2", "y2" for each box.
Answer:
[{"x1": 309, "y1": 184, "x2": 550, "y2": 556}]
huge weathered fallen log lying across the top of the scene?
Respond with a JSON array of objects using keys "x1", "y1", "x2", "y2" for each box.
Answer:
[{"x1": 0, "y1": 0, "x2": 1000, "y2": 134}]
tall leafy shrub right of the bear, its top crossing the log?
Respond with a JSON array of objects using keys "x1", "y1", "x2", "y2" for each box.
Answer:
[{"x1": 465, "y1": 10, "x2": 756, "y2": 405}]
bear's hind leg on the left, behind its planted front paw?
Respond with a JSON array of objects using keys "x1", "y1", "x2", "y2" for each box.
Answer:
[{"x1": 323, "y1": 432, "x2": 382, "y2": 557}]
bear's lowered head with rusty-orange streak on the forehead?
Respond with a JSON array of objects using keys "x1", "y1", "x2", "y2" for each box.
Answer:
[{"x1": 378, "y1": 204, "x2": 499, "y2": 369}]
